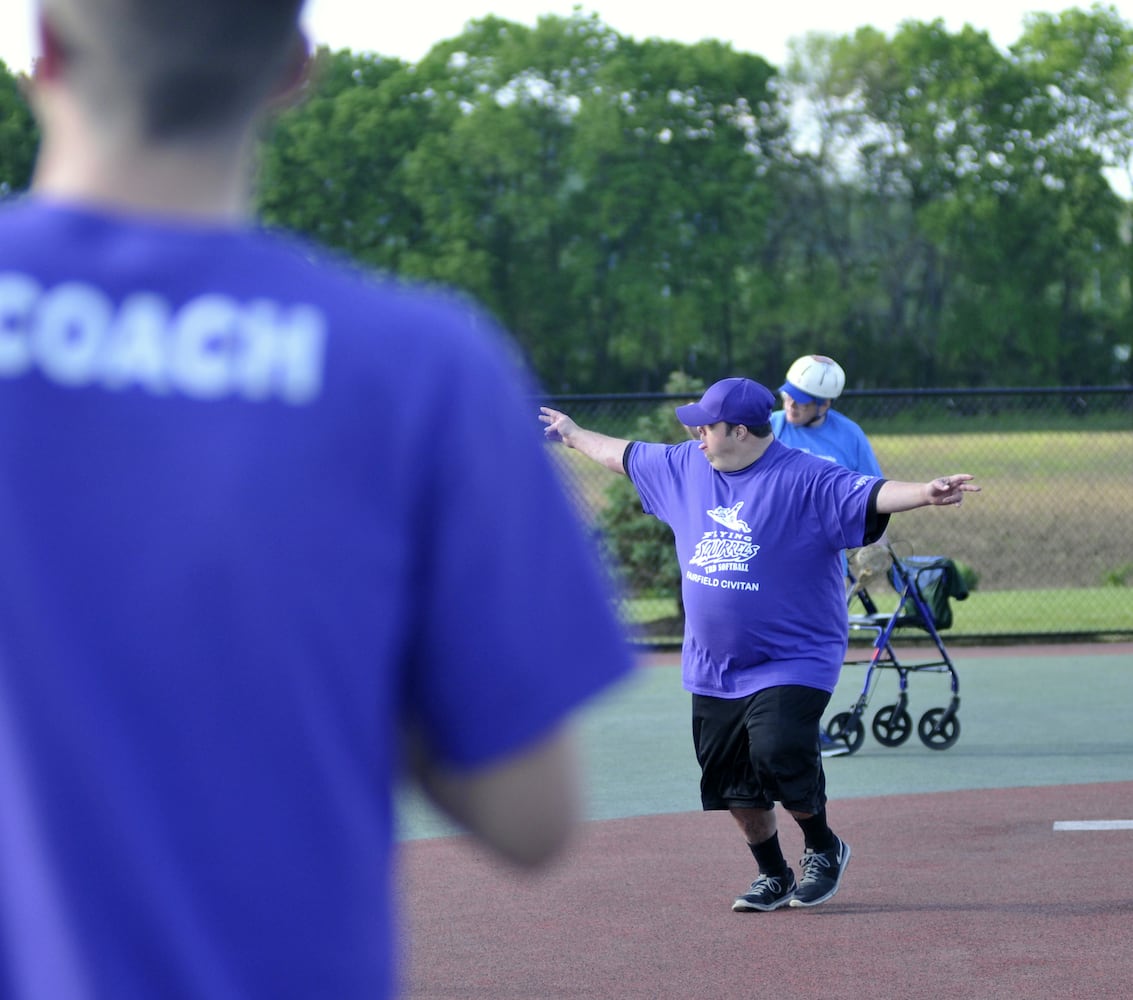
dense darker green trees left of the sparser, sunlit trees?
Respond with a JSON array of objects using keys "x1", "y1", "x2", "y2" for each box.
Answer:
[{"x1": 262, "y1": 14, "x2": 782, "y2": 391}]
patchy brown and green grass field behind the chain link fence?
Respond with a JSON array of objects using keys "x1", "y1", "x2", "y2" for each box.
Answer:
[{"x1": 553, "y1": 423, "x2": 1133, "y2": 639}]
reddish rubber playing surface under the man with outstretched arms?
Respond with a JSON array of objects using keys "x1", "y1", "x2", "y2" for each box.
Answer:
[{"x1": 402, "y1": 647, "x2": 1133, "y2": 1000}]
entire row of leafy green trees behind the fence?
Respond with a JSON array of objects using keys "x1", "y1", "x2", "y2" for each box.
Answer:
[{"x1": 254, "y1": 7, "x2": 1133, "y2": 393}]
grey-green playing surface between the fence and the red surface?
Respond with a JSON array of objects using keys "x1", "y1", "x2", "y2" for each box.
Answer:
[{"x1": 401, "y1": 643, "x2": 1133, "y2": 838}]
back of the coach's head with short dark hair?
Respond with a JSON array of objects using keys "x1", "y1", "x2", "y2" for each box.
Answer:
[{"x1": 41, "y1": 0, "x2": 304, "y2": 142}]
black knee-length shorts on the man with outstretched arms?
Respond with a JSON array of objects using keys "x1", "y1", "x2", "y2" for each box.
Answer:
[{"x1": 692, "y1": 684, "x2": 830, "y2": 813}]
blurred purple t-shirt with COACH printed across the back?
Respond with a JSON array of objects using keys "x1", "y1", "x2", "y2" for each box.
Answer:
[{"x1": 0, "y1": 198, "x2": 631, "y2": 1000}]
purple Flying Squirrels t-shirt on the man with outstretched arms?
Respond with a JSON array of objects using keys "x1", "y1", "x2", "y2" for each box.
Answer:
[{"x1": 627, "y1": 441, "x2": 885, "y2": 698}]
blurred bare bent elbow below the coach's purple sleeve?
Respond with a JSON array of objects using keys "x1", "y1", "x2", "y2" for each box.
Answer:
[{"x1": 408, "y1": 725, "x2": 582, "y2": 866}]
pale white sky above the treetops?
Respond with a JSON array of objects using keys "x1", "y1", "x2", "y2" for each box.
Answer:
[{"x1": 0, "y1": 0, "x2": 1133, "y2": 70}]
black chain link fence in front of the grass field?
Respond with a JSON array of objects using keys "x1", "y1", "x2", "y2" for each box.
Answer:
[{"x1": 547, "y1": 386, "x2": 1133, "y2": 646}]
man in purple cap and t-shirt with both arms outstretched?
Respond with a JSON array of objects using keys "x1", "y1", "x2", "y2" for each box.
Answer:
[{"x1": 540, "y1": 378, "x2": 979, "y2": 911}]
